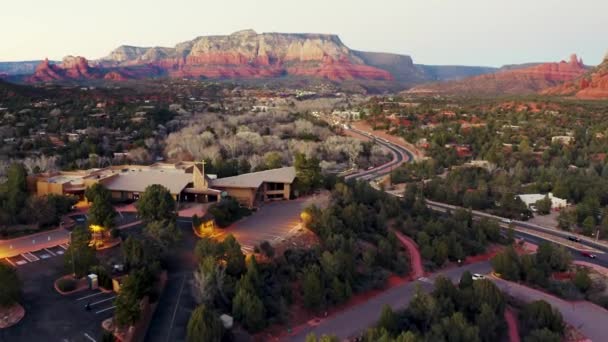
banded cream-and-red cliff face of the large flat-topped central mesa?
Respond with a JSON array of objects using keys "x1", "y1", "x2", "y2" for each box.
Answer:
[{"x1": 95, "y1": 30, "x2": 393, "y2": 81}]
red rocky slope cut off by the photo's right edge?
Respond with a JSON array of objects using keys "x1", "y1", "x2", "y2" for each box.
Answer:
[{"x1": 543, "y1": 55, "x2": 608, "y2": 99}]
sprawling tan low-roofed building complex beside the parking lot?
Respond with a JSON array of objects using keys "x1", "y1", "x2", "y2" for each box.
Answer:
[{"x1": 29, "y1": 162, "x2": 296, "y2": 208}]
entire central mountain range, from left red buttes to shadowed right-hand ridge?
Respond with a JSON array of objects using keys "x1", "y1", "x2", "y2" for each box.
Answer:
[{"x1": 20, "y1": 30, "x2": 504, "y2": 89}]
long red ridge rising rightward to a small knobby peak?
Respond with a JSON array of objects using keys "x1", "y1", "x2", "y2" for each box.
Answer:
[{"x1": 408, "y1": 55, "x2": 587, "y2": 96}]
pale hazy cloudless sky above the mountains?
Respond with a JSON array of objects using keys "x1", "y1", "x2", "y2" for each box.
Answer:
[{"x1": 0, "y1": 0, "x2": 608, "y2": 66}]
